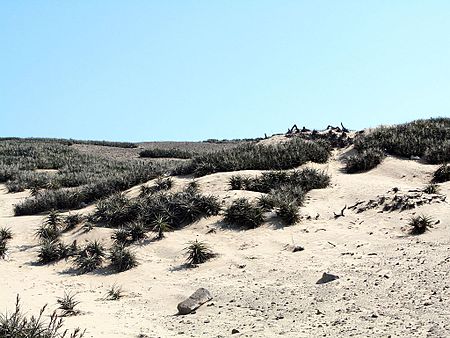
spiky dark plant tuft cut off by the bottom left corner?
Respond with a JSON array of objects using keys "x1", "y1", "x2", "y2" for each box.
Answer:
[{"x1": 0, "y1": 296, "x2": 85, "y2": 338}]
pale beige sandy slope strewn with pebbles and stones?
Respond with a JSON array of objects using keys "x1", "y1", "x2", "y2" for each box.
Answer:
[{"x1": 0, "y1": 149, "x2": 450, "y2": 338}]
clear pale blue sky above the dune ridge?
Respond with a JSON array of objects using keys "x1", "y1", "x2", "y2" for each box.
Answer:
[{"x1": 0, "y1": 0, "x2": 450, "y2": 141}]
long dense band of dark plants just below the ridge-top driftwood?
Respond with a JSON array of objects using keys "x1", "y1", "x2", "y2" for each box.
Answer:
[{"x1": 173, "y1": 137, "x2": 330, "y2": 176}]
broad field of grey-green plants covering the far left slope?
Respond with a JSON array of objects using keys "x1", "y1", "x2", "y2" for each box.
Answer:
[{"x1": 0, "y1": 140, "x2": 168, "y2": 215}]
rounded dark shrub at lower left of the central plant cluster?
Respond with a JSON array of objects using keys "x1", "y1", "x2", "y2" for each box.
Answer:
[{"x1": 224, "y1": 198, "x2": 264, "y2": 229}]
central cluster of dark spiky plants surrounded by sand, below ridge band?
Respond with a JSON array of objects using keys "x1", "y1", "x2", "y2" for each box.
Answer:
[{"x1": 229, "y1": 168, "x2": 330, "y2": 228}]
